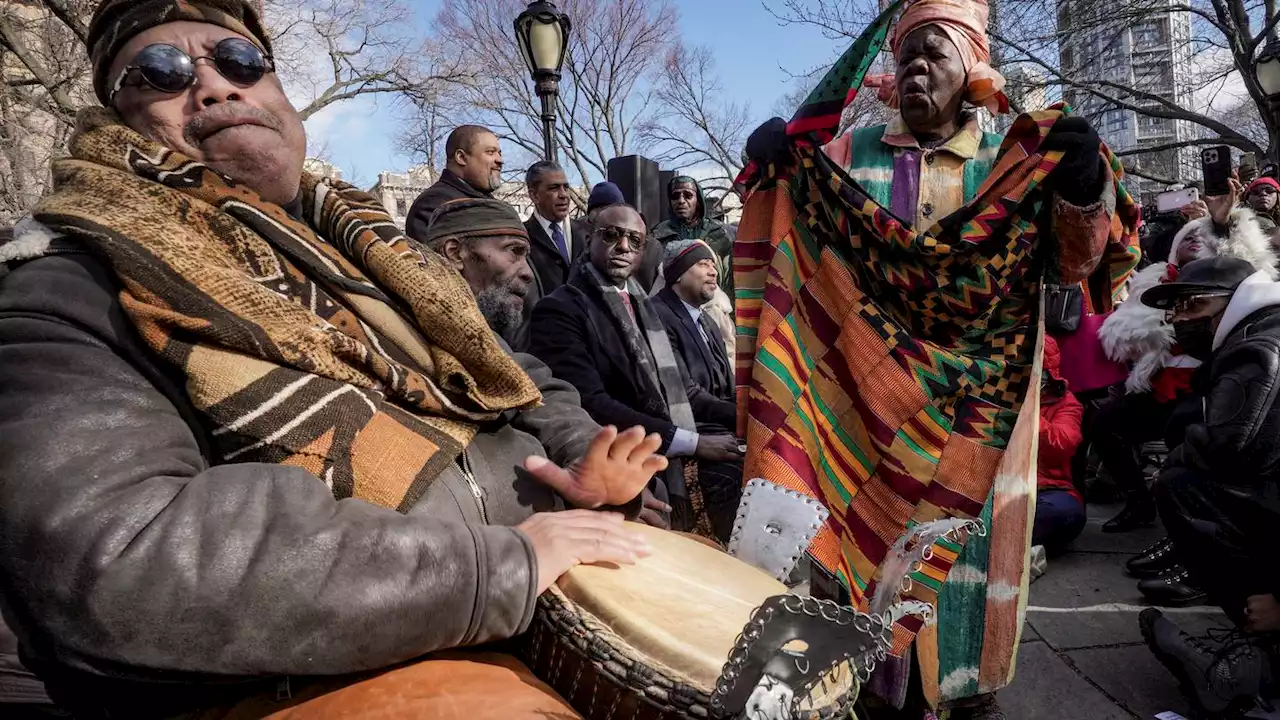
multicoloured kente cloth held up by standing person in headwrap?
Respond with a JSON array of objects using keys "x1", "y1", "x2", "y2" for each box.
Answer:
[{"x1": 733, "y1": 3, "x2": 1138, "y2": 702}]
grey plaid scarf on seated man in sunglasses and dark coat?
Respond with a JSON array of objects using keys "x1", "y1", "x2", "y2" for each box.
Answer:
[{"x1": 582, "y1": 263, "x2": 698, "y2": 432}]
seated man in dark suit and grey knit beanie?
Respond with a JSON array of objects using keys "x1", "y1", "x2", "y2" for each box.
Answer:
[{"x1": 653, "y1": 240, "x2": 735, "y2": 402}]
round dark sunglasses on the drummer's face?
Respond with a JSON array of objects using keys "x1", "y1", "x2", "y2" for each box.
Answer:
[{"x1": 110, "y1": 37, "x2": 275, "y2": 100}]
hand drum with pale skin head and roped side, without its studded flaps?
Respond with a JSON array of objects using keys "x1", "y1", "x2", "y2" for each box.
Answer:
[{"x1": 522, "y1": 524, "x2": 786, "y2": 720}]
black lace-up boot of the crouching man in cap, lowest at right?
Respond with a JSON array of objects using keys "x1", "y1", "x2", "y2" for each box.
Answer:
[{"x1": 1138, "y1": 607, "x2": 1271, "y2": 717}]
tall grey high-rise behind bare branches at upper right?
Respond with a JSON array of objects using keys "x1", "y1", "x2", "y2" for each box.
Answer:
[{"x1": 1057, "y1": 0, "x2": 1199, "y2": 204}]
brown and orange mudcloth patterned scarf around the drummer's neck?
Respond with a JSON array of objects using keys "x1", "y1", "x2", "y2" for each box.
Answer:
[{"x1": 33, "y1": 109, "x2": 541, "y2": 510}]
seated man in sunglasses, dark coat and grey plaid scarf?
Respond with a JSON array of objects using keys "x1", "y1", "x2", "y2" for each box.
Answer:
[{"x1": 529, "y1": 205, "x2": 742, "y2": 539}]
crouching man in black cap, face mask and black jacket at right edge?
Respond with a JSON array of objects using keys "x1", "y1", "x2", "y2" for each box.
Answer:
[{"x1": 1139, "y1": 256, "x2": 1280, "y2": 717}]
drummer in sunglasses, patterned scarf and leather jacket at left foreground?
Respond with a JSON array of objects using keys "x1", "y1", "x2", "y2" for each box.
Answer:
[{"x1": 0, "y1": 0, "x2": 667, "y2": 719}]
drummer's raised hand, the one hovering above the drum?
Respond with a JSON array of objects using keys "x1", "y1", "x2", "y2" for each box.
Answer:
[{"x1": 525, "y1": 425, "x2": 667, "y2": 509}]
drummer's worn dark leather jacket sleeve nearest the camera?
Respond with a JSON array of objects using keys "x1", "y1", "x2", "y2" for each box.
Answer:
[{"x1": 0, "y1": 255, "x2": 536, "y2": 680}]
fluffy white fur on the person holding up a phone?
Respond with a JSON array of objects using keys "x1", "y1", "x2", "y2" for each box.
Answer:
[{"x1": 1098, "y1": 206, "x2": 1276, "y2": 393}]
